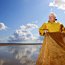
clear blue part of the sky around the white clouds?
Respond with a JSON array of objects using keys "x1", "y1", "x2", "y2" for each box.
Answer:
[{"x1": 0, "y1": 0, "x2": 65, "y2": 40}]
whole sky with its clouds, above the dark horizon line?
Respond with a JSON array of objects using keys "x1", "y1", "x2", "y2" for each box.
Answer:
[{"x1": 0, "y1": 0, "x2": 65, "y2": 43}]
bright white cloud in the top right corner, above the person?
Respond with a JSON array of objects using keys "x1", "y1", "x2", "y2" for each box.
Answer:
[{"x1": 49, "y1": 0, "x2": 65, "y2": 11}]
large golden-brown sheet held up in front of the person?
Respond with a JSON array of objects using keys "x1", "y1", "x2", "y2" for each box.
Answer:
[{"x1": 36, "y1": 32, "x2": 65, "y2": 65}]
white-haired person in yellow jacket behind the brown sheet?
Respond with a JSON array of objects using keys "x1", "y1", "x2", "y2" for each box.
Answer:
[{"x1": 39, "y1": 12, "x2": 65, "y2": 36}]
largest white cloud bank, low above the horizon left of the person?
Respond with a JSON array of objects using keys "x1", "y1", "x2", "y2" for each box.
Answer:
[{"x1": 8, "y1": 23, "x2": 38, "y2": 42}]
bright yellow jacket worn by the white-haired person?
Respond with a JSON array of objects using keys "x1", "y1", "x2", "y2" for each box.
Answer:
[{"x1": 39, "y1": 21, "x2": 65, "y2": 36}]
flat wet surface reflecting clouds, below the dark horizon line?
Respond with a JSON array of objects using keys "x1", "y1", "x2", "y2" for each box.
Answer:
[{"x1": 0, "y1": 45, "x2": 41, "y2": 65}]
